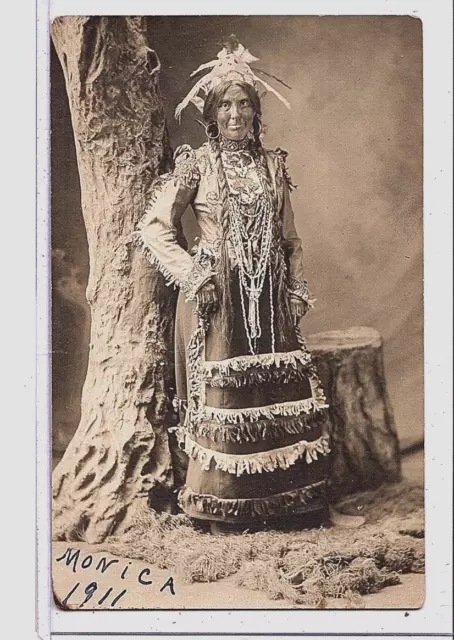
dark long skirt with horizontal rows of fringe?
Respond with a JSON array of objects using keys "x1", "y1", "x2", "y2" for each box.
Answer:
[{"x1": 175, "y1": 276, "x2": 329, "y2": 525}]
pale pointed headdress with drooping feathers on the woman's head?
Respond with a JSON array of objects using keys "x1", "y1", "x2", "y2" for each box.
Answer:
[{"x1": 175, "y1": 35, "x2": 290, "y2": 121}]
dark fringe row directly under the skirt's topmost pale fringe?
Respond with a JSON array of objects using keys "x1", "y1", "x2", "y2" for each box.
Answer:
[{"x1": 205, "y1": 364, "x2": 315, "y2": 389}]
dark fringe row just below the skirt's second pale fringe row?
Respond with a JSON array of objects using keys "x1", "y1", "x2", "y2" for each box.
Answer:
[{"x1": 180, "y1": 409, "x2": 328, "y2": 443}]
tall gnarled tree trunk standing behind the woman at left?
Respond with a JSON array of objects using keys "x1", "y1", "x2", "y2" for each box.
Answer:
[{"x1": 52, "y1": 17, "x2": 175, "y2": 543}]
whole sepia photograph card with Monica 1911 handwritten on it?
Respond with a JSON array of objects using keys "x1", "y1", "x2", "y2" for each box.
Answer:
[{"x1": 49, "y1": 15, "x2": 425, "y2": 611}]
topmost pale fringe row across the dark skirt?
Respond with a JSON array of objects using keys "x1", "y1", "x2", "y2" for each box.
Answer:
[{"x1": 203, "y1": 349, "x2": 312, "y2": 379}]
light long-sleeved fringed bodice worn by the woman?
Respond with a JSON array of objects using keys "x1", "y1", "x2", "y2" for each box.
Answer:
[{"x1": 134, "y1": 140, "x2": 304, "y2": 299}]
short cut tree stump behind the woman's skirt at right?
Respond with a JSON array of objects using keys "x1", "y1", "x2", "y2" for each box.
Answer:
[{"x1": 307, "y1": 327, "x2": 401, "y2": 499}]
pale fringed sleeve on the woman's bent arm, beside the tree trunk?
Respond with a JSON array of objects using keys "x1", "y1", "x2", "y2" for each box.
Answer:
[{"x1": 134, "y1": 145, "x2": 212, "y2": 300}]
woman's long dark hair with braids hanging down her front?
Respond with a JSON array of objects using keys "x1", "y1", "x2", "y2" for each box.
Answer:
[{"x1": 203, "y1": 80, "x2": 286, "y2": 350}]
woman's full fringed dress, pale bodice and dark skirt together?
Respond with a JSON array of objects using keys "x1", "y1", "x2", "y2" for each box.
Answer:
[{"x1": 135, "y1": 135, "x2": 329, "y2": 526}]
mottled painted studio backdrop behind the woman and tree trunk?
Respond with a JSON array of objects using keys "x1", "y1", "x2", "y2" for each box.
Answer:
[{"x1": 51, "y1": 16, "x2": 423, "y2": 457}]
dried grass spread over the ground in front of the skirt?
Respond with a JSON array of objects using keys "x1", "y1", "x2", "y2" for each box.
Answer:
[{"x1": 97, "y1": 483, "x2": 424, "y2": 608}]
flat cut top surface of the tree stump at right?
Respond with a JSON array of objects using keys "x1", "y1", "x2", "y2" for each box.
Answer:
[{"x1": 307, "y1": 327, "x2": 382, "y2": 352}]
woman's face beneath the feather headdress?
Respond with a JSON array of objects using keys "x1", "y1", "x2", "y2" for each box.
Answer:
[{"x1": 217, "y1": 85, "x2": 255, "y2": 140}]
